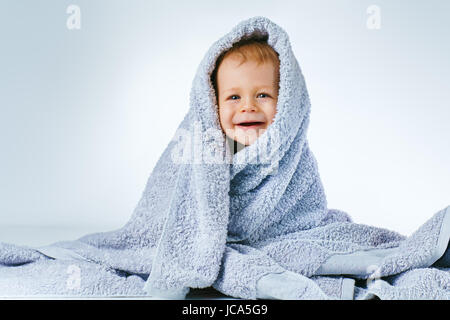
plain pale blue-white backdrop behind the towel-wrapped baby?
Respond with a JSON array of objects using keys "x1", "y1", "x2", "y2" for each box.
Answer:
[{"x1": 0, "y1": 0, "x2": 450, "y2": 245}]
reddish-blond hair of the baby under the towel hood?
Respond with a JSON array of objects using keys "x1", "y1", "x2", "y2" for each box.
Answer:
[{"x1": 211, "y1": 38, "x2": 280, "y2": 98}]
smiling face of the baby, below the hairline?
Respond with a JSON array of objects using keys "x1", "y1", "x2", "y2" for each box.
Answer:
[{"x1": 217, "y1": 55, "x2": 278, "y2": 146}]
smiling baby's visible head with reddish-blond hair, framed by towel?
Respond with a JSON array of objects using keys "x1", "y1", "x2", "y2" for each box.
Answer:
[{"x1": 211, "y1": 39, "x2": 280, "y2": 153}]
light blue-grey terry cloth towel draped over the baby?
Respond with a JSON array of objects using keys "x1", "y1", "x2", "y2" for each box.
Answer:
[{"x1": 0, "y1": 16, "x2": 450, "y2": 299}]
